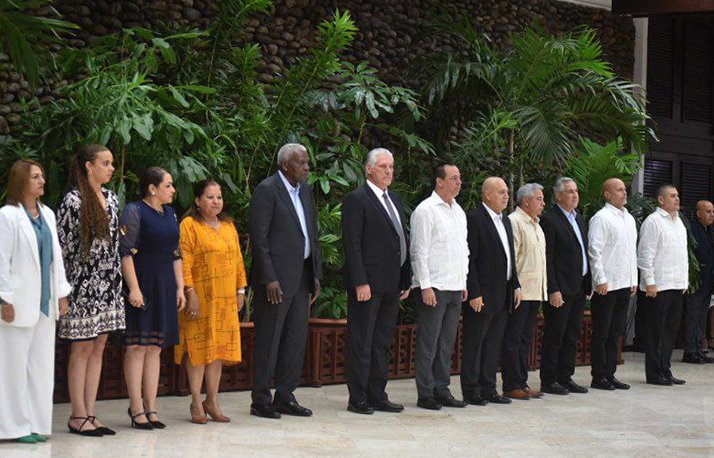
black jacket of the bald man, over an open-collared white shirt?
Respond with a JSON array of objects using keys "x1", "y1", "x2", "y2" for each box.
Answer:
[{"x1": 466, "y1": 204, "x2": 520, "y2": 313}]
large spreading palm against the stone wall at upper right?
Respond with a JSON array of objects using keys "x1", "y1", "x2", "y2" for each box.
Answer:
[{"x1": 420, "y1": 17, "x2": 654, "y2": 202}]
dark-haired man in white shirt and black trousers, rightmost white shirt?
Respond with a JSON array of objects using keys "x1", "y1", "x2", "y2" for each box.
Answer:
[{"x1": 637, "y1": 185, "x2": 689, "y2": 385}]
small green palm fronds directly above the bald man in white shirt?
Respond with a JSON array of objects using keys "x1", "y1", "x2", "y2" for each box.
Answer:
[{"x1": 563, "y1": 138, "x2": 641, "y2": 219}]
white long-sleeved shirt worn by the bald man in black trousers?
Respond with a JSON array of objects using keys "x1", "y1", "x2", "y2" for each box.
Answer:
[{"x1": 588, "y1": 203, "x2": 637, "y2": 291}]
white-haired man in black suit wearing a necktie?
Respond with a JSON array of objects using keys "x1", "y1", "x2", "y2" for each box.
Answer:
[{"x1": 342, "y1": 148, "x2": 411, "y2": 414}]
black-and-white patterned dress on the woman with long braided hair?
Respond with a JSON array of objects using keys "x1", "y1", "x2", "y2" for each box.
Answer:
[{"x1": 57, "y1": 188, "x2": 125, "y2": 340}]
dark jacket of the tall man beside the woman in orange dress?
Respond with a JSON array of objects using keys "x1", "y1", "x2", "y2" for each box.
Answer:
[{"x1": 249, "y1": 172, "x2": 322, "y2": 297}]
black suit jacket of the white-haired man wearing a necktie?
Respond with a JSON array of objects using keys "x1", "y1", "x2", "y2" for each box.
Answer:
[{"x1": 342, "y1": 183, "x2": 412, "y2": 292}]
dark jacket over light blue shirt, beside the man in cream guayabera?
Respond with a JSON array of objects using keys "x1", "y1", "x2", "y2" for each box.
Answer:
[{"x1": 540, "y1": 205, "x2": 592, "y2": 296}]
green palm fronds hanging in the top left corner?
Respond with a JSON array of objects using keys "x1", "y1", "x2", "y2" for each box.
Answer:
[{"x1": 0, "y1": 0, "x2": 77, "y2": 86}]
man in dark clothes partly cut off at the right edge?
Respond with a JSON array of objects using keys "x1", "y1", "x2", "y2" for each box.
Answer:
[{"x1": 682, "y1": 200, "x2": 714, "y2": 364}]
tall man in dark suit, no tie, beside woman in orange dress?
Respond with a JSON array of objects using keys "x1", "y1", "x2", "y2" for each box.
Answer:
[{"x1": 250, "y1": 143, "x2": 321, "y2": 418}]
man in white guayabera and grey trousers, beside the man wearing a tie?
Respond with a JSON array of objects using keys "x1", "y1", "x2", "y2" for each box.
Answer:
[{"x1": 410, "y1": 164, "x2": 469, "y2": 410}]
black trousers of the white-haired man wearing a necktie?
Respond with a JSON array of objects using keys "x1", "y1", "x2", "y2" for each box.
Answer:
[{"x1": 347, "y1": 288, "x2": 400, "y2": 403}]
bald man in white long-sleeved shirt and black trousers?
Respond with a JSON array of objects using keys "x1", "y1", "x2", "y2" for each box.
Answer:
[{"x1": 588, "y1": 178, "x2": 637, "y2": 390}]
